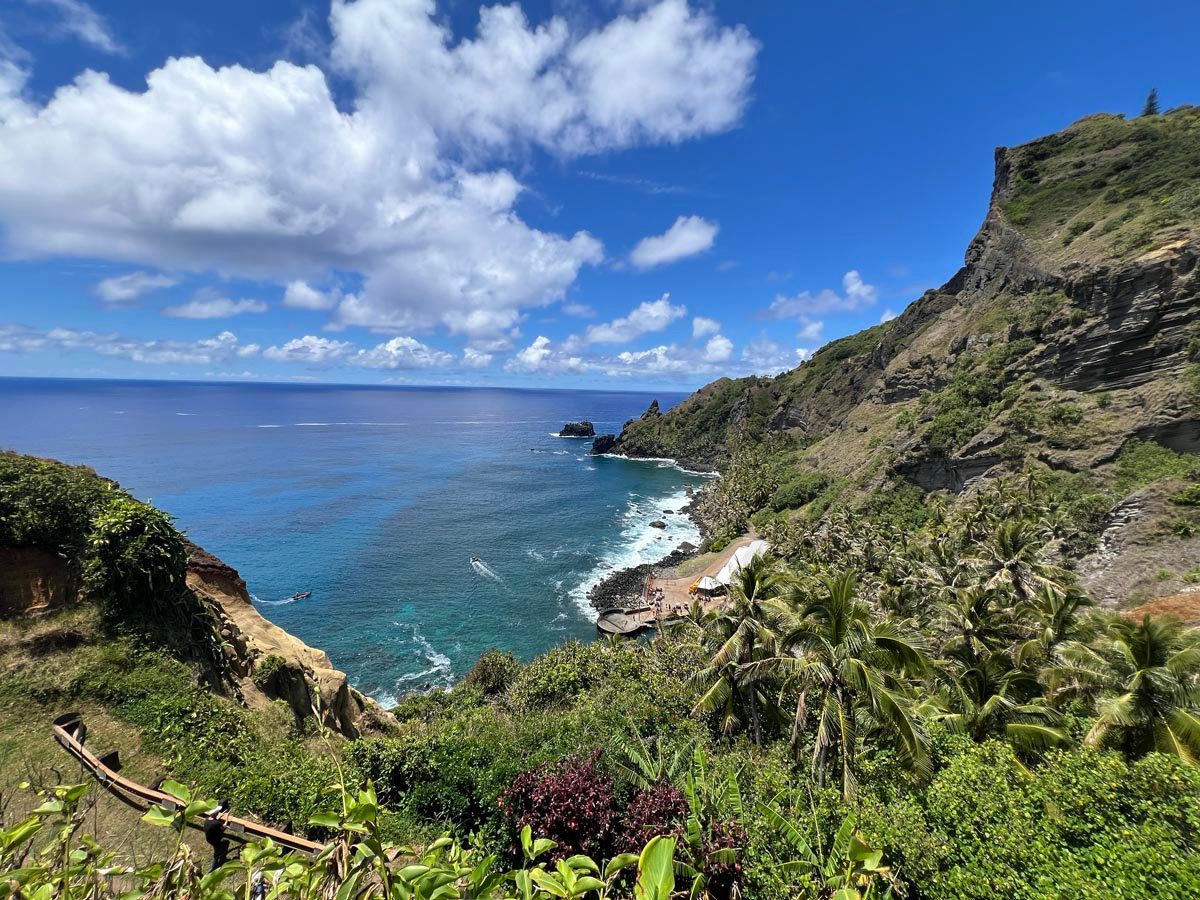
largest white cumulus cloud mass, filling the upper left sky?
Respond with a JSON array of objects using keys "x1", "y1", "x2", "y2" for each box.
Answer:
[{"x1": 0, "y1": 0, "x2": 757, "y2": 346}]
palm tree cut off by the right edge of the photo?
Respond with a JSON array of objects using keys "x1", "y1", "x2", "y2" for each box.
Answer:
[{"x1": 1052, "y1": 616, "x2": 1200, "y2": 766}]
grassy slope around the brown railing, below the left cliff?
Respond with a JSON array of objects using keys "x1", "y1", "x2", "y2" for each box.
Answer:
[{"x1": 0, "y1": 592, "x2": 340, "y2": 851}]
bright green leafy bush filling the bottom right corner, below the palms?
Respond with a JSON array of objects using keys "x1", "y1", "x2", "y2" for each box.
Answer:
[{"x1": 866, "y1": 743, "x2": 1200, "y2": 900}]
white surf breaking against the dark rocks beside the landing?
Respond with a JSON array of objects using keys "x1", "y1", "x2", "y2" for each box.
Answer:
[{"x1": 568, "y1": 491, "x2": 700, "y2": 622}]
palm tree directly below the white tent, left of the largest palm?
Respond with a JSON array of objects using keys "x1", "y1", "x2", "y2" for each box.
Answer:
[{"x1": 692, "y1": 553, "x2": 781, "y2": 744}]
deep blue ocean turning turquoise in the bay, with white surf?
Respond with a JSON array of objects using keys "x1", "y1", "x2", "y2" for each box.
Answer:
[{"x1": 0, "y1": 378, "x2": 703, "y2": 702}]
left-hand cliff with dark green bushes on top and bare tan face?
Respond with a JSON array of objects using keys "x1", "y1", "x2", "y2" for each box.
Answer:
[{"x1": 0, "y1": 452, "x2": 390, "y2": 737}]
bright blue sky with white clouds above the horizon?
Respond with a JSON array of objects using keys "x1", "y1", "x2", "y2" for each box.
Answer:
[{"x1": 0, "y1": 0, "x2": 1200, "y2": 389}]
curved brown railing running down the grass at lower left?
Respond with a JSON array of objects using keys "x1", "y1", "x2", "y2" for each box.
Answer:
[{"x1": 54, "y1": 713, "x2": 325, "y2": 856}]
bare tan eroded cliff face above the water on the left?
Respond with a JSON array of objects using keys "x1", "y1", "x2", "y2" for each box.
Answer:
[{"x1": 187, "y1": 545, "x2": 391, "y2": 737}]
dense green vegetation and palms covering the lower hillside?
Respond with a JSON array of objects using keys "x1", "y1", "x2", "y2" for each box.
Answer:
[{"x1": 9, "y1": 458, "x2": 1200, "y2": 898}]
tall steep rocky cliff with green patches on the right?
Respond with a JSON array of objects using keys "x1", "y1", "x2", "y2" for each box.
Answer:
[{"x1": 608, "y1": 107, "x2": 1200, "y2": 497}]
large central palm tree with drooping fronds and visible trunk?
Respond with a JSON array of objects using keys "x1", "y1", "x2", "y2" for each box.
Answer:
[{"x1": 752, "y1": 570, "x2": 926, "y2": 798}]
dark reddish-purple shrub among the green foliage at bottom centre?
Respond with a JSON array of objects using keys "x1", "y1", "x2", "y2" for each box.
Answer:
[{"x1": 500, "y1": 750, "x2": 617, "y2": 859}]
